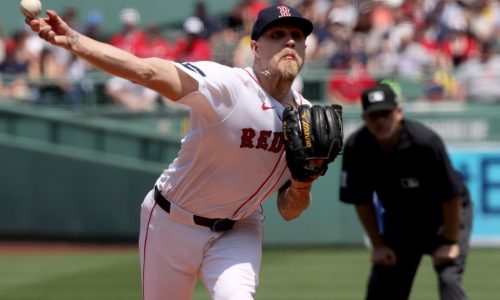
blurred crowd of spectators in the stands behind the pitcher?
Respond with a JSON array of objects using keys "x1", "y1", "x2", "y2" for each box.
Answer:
[{"x1": 0, "y1": 0, "x2": 500, "y2": 111}]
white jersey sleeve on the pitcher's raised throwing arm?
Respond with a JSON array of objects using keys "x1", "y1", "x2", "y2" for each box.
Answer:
[{"x1": 175, "y1": 61, "x2": 242, "y2": 124}]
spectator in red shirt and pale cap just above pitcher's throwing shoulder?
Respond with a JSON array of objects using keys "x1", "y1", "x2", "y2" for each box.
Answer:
[{"x1": 174, "y1": 17, "x2": 212, "y2": 62}]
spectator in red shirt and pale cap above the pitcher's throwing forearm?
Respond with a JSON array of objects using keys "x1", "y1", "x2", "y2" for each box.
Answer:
[{"x1": 109, "y1": 8, "x2": 146, "y2": 55}]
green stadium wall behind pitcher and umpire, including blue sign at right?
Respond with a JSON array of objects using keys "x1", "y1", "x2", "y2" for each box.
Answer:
[{"x1": 0, "y1": 101, "x2": 500, "y2": 246}]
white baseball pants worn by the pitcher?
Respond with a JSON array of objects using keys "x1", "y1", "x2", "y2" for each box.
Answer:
[{"x1": 139, "y1": 191, "x2": 264, "y2": 300}]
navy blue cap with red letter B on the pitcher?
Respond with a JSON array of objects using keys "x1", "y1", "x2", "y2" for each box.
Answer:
[{"x1": 252, "y1": 5, "x2": 313, "y2": 41}]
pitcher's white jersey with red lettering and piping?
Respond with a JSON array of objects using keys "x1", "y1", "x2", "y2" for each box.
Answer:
[{"x1": 156, "y1": 61, "x2": 310, "y2": 220}]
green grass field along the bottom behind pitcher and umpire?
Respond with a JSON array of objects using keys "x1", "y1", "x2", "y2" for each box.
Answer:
[{"x1": 0, "y1": 248, "x2": 500, "y2": 300}]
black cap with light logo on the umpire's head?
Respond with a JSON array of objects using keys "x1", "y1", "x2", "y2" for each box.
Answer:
[{"x1": 361, "y1": 83, "x2": 398, "y2": 116}]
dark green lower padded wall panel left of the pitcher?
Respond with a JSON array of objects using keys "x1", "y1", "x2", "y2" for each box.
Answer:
[{"x1": 0, "y1": 134, "x2": 163, "y2": 241}]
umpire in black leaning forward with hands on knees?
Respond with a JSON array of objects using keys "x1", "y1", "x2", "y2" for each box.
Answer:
[{"x1": 340, "y1": 84, "x2": 472, "y2": 300}]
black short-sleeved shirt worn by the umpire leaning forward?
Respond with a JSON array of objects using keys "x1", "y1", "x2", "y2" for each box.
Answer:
[{"x1": 340, "y1": 120, "x2": 470, "y2": 243}]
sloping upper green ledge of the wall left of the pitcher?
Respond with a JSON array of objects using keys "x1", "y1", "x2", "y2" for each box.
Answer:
[{"x1": 0, "y1": 102, "x2": 188, "y2": 162}]
